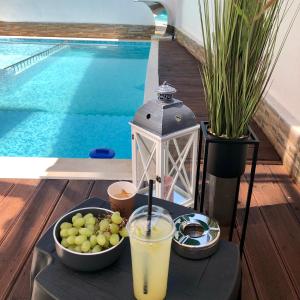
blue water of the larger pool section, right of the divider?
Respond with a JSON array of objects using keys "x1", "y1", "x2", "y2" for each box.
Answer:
[{"x1": 0, "y1": 42, "x2": 150, "y2": 158}]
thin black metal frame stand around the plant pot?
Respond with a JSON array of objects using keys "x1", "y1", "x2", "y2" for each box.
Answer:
[{"x1": 194, "y1": 122, "x2": 259, "y2": 254}]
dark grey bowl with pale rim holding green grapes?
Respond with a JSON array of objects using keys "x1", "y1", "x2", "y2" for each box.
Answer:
[{"x1": 53, "y1": 207, "x2": 125, "y2": 272}]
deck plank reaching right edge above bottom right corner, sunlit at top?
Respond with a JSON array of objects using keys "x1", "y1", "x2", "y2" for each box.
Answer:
[{"x1": 244, "y1": 165, "x2": 300, "y2": 298}]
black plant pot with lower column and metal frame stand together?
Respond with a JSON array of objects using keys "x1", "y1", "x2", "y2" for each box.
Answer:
[{"x1": 194, "y1": 121, "x2": 259, "y2": 246}]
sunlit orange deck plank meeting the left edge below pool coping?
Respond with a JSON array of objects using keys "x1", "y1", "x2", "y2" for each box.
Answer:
[{"x1": 0, "y1": 180, "x2": 40, "y2": 245}]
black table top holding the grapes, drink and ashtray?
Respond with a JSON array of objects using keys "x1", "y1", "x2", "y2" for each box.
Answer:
[{"x1": 31, "y1": 195, "x2": 241, "y2": 300}]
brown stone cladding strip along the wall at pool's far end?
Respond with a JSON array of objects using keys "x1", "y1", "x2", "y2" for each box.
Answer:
[{"x1": 0, "y1": 22, "x2": 155, "y2": 40}]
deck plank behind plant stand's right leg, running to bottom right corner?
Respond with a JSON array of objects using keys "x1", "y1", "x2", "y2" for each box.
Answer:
[{"x1": 237, "y1": 175, "x2": 298, "y2": 300}]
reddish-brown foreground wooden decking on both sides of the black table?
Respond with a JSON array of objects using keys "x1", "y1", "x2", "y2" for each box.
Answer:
[{"x1": 0, "y1": 170, "x2": 300, "y2": 300}]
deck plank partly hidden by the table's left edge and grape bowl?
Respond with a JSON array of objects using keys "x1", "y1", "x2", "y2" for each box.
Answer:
[{"x1": 8, "y1": 180, "x2": 94, "y2": 300}]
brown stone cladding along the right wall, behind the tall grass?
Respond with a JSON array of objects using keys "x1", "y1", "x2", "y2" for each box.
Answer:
[{"x1": 175, "y1": 28, "x2": 300, "y2": 183}]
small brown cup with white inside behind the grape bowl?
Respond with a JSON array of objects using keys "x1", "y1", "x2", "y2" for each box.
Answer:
[{"x1": 107, "y1": 181, "x2": 137, "y2": 218}]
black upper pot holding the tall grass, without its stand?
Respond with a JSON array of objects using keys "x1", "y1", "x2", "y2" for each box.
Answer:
[{"x1": 207, "y1": 133, "x2": 248, "y2": 178}]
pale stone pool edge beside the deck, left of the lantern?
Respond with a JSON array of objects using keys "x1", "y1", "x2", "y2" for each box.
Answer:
[{"x1": 0, "y1": 156, "x2": 131, "y2": 180}]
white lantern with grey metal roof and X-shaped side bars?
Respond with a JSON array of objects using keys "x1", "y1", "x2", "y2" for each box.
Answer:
[{"x1": 130, "y1": 83, "x2": 199, "y2": 206}]
